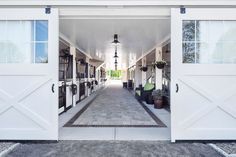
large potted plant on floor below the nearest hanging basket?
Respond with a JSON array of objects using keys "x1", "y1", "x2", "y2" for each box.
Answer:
[{"x1": 152, "y1": 89, "x2": 164, "y2": 109}]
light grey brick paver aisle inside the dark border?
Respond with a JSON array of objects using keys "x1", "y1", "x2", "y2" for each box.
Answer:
[{"x1": 73, "y1": 84, "x2": 161, "y2": 126}]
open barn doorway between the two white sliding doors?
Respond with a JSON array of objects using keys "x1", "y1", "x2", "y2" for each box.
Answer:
[{"x1": 56, "y1": 18, "x2": 170, "y2": 140}]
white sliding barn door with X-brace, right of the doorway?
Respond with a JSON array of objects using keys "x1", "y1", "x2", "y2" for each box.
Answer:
[{"x1": 171, "y1": 8, "x2": 236, "y2": 141}]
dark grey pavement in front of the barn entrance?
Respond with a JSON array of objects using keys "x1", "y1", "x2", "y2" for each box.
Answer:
[{"x1": 7, "y1": 141, "x2": 222, "y2": 157}]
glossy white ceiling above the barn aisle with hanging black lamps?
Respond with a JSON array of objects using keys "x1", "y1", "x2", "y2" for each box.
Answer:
[{"x1": 60, "y1": 19, "x2": 170, "y2": 68}]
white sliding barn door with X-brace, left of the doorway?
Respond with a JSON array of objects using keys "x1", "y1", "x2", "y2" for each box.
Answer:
[{"x1": 0, "y1": 8, "x2": 58, "y2": 140}]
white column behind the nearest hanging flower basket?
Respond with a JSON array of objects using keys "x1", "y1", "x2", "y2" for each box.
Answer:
[{"x1": 155, "y1": 47, "x2": 162, "y2": 89}]
